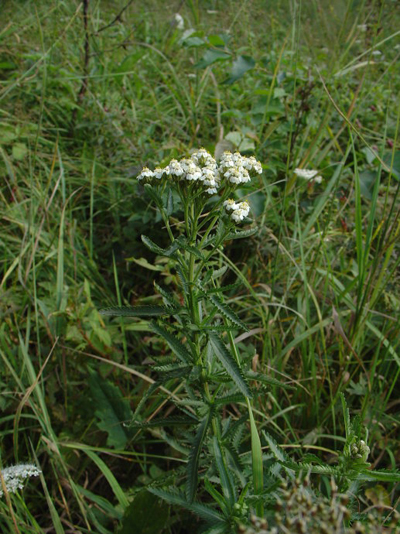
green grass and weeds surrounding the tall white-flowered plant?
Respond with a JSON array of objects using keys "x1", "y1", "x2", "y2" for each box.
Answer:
[{"x1": 0, "y1": 0, "x2": 400, "y2": 534}]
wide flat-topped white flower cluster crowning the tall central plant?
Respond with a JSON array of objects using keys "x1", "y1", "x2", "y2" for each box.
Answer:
[{"x1": 138, "y1": 148, "x2": 262, "y2": 195}]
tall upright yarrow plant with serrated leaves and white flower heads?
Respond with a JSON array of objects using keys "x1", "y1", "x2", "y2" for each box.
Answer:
[{"x1": 102, "y1": 148, "x2": 263, "y2": 532}]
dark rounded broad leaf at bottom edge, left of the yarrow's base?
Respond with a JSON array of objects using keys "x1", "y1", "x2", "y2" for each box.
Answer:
[{"x1": 118, "y1": 490, "x2": 169, "y2": 534}]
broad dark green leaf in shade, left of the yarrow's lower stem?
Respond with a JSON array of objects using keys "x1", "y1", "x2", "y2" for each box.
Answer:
[{"x1": 89, "y1": 371, "x2": 132, "y2": 450}]
